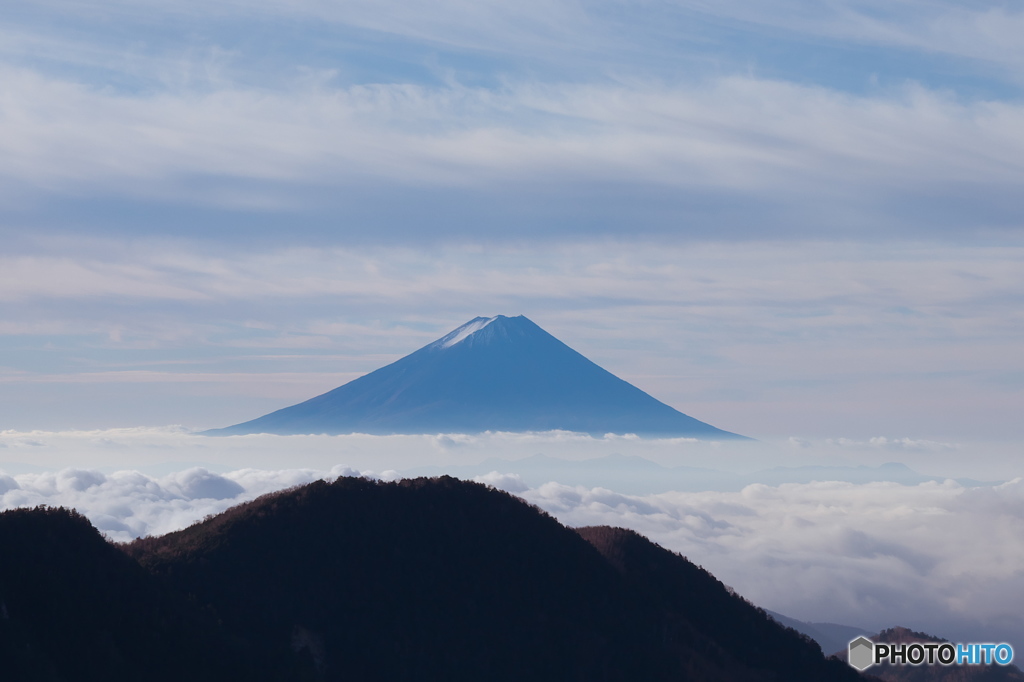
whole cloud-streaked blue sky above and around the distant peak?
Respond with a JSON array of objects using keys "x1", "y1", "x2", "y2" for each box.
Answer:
[{"x1": 0, "y1": 0, "x2": 1024, "y2": 441}]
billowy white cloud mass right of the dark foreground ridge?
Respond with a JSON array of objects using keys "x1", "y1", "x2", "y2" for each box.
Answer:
[{"x1": 523, "y1": 479, "x2": 1024, "y2": 642}]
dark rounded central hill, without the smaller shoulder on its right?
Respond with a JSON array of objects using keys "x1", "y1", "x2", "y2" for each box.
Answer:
[{"x1": 128, "y1": 478, "x2": 671, "y2": 680}]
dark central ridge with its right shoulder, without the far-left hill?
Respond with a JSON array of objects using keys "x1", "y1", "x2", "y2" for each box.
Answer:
[{"x1": 127, "y1": 477, "x2": 860, "y2": 682}]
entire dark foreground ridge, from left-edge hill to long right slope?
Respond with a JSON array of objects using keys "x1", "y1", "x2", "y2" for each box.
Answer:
[{"x1": 0, "y1": 477, "x2": 862, "y2": 682}]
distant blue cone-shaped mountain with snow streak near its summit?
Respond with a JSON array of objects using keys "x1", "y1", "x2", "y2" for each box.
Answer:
[{"x1": 205, "y1": 315, "x2": 743, "y2": 439}]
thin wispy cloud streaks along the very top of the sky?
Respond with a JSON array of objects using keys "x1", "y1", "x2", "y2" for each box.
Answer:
[{"x1": 17, "y1": 0, "x2": 1021, "y2": 77}]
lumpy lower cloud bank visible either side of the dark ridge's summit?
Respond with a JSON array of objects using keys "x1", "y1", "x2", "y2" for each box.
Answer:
[{"x1": 0, "y1": 446, "x2": 1024, "y2": 644}]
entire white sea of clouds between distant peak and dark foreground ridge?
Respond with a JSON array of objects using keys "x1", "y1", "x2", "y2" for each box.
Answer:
[{"x1": 0, "y1": 428, "x2": 1024, "y2": 645}]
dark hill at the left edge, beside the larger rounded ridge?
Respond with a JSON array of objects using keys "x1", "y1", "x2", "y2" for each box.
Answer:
[{"x1": 0, "y1": 501, "x2": 254, "y2": 682}]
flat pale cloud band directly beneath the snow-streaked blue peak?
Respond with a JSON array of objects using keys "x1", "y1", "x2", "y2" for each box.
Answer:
[{"x1": 0, "y1": 427, "x2": 1024, "y2": 475}]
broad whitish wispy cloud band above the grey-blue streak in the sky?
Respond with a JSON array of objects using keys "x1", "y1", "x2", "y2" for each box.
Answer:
[{"x1": 0, "y1": 68, "x2": 1024, "y2": 235}]
